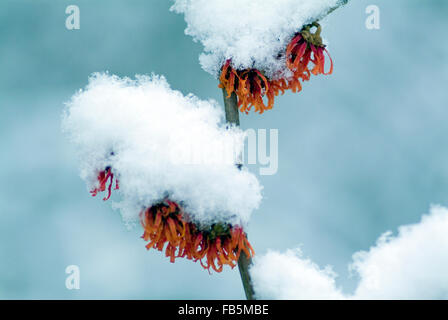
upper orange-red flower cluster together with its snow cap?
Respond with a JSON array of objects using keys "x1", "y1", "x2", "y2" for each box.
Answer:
[{"x1": 172, "y1": 0, "x2": 347, "y2": 114}]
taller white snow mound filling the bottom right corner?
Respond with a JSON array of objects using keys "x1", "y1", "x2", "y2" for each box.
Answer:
[{"x1": 351, "y1": 206, "x2": 448, "y2": 299}]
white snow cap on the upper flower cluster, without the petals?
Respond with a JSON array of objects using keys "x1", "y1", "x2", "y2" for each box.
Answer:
[{"x1": 171, "y1": 0, "x2": 342, "y2": 79}]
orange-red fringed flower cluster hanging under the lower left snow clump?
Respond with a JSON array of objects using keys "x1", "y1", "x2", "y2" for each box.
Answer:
[{"x1": 140, "y1": 199, "x2": 254, "y2": 272}]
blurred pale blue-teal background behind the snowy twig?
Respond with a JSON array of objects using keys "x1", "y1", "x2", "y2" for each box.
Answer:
[{"x1": 0, "y1": 0, "x2": 448, "y2": 299}]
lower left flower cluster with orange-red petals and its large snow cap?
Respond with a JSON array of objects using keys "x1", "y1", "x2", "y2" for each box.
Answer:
[{"x1": 63, "y1": 74, "x2": 261, "y2": 272}]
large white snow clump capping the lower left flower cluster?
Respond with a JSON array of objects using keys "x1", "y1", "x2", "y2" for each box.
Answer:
[{"x1": 63, "y1": 74, "x2": 261, "y2": 224}]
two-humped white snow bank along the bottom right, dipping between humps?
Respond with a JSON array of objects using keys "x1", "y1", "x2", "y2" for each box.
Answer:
[{"x1": 251, "y1": 206, "x2": 448, "y2": 299}]
